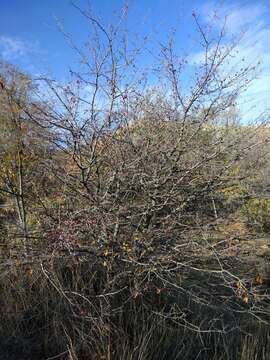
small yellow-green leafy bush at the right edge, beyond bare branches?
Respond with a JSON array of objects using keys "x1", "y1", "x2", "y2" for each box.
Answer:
[{"x1": 242, "y1": 199, "x2": 270, "y2": 231}]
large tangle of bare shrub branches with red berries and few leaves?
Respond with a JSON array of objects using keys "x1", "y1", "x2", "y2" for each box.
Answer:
[{"x1": 0, "y1": 5, "x2": 269, "y2": 359}]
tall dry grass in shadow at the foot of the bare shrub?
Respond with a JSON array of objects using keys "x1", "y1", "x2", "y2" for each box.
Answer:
[{"x1": 0, "y1": 255, "x2": 270, "y2": 360}]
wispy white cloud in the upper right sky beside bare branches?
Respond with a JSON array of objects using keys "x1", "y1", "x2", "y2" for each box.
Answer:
[{"x1": 193, "y1": 1, "x2": 270, "y2": 119}]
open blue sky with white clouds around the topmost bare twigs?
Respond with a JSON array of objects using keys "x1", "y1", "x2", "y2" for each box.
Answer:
[{"x1": 0, "y1": 0, "x2": 270, "y2": 120}]
